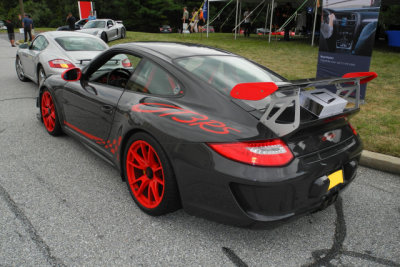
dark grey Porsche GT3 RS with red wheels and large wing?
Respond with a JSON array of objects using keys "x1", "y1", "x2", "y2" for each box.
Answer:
[{"x1": 37, "y1": 42, "x2": 376, "y2": 226}]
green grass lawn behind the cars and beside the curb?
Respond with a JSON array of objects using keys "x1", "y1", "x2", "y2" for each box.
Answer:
[{"x1": 8, "y1": 29, "x2": 400, "y2": 157}]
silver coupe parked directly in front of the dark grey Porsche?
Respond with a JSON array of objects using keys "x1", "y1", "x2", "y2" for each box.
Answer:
[{"x1": 15, "y1": 31, "x2": 108, "y2": 85}]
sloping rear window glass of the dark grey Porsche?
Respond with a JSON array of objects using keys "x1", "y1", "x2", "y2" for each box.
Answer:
[{"x1": 176, "y1": 56, "x2": 282, "y2": 94}]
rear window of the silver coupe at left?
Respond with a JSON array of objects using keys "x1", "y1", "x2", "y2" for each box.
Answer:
[{"x1": 55, "y1": 36, "x2": 107, "y2": 51}]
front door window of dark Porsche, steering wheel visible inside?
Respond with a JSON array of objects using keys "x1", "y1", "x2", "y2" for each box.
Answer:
[{"x1": 89, "y1": 53, "x2": 141, "y2": 88}]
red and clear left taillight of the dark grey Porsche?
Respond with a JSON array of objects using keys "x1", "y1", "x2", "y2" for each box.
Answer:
[{"x1": 208, "y1": 139, "x2": 293, "y2": 166}]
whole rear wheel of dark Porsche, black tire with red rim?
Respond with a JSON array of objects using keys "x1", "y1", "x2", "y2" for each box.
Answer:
[{"x1": 122, "y1": 133, "x2": 181, "y2": 216}]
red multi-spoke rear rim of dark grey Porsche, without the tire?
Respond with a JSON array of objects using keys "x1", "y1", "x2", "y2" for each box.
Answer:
[{"x1": 126, "y1": 140, "x2": 165, "y2": 209}]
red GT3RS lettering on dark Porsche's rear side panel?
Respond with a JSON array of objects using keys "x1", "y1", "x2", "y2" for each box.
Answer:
[{"x1": 132, "y1": 103, "x2": 240, "y2": 134}]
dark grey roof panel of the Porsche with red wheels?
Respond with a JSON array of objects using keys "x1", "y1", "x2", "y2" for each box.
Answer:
[{"x1": 114, "y1": 42, "x2": 234, "y2": 59}]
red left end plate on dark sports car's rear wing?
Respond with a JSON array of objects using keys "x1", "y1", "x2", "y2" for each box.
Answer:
[{"x1": 231, "y1": 82, "x2": 278, "y2": 101}]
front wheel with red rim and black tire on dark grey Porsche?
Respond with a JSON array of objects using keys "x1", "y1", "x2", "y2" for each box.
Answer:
[{"x1": 40, "y1": 89, "x2": 62, "y2": 136}]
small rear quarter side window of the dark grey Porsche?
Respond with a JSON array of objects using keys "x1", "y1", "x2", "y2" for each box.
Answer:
[{"x1": 126, "y1": 60, "x2": 183, "y2": 95}]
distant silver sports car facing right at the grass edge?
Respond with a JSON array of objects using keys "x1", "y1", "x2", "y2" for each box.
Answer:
[{"x1": 78, "y1": 19, "x2": 126, "y2": 43}]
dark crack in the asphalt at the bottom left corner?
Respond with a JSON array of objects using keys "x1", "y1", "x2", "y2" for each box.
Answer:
[{"x1": 0, "y1": 184, "x2": 66, "y2": 266}]
